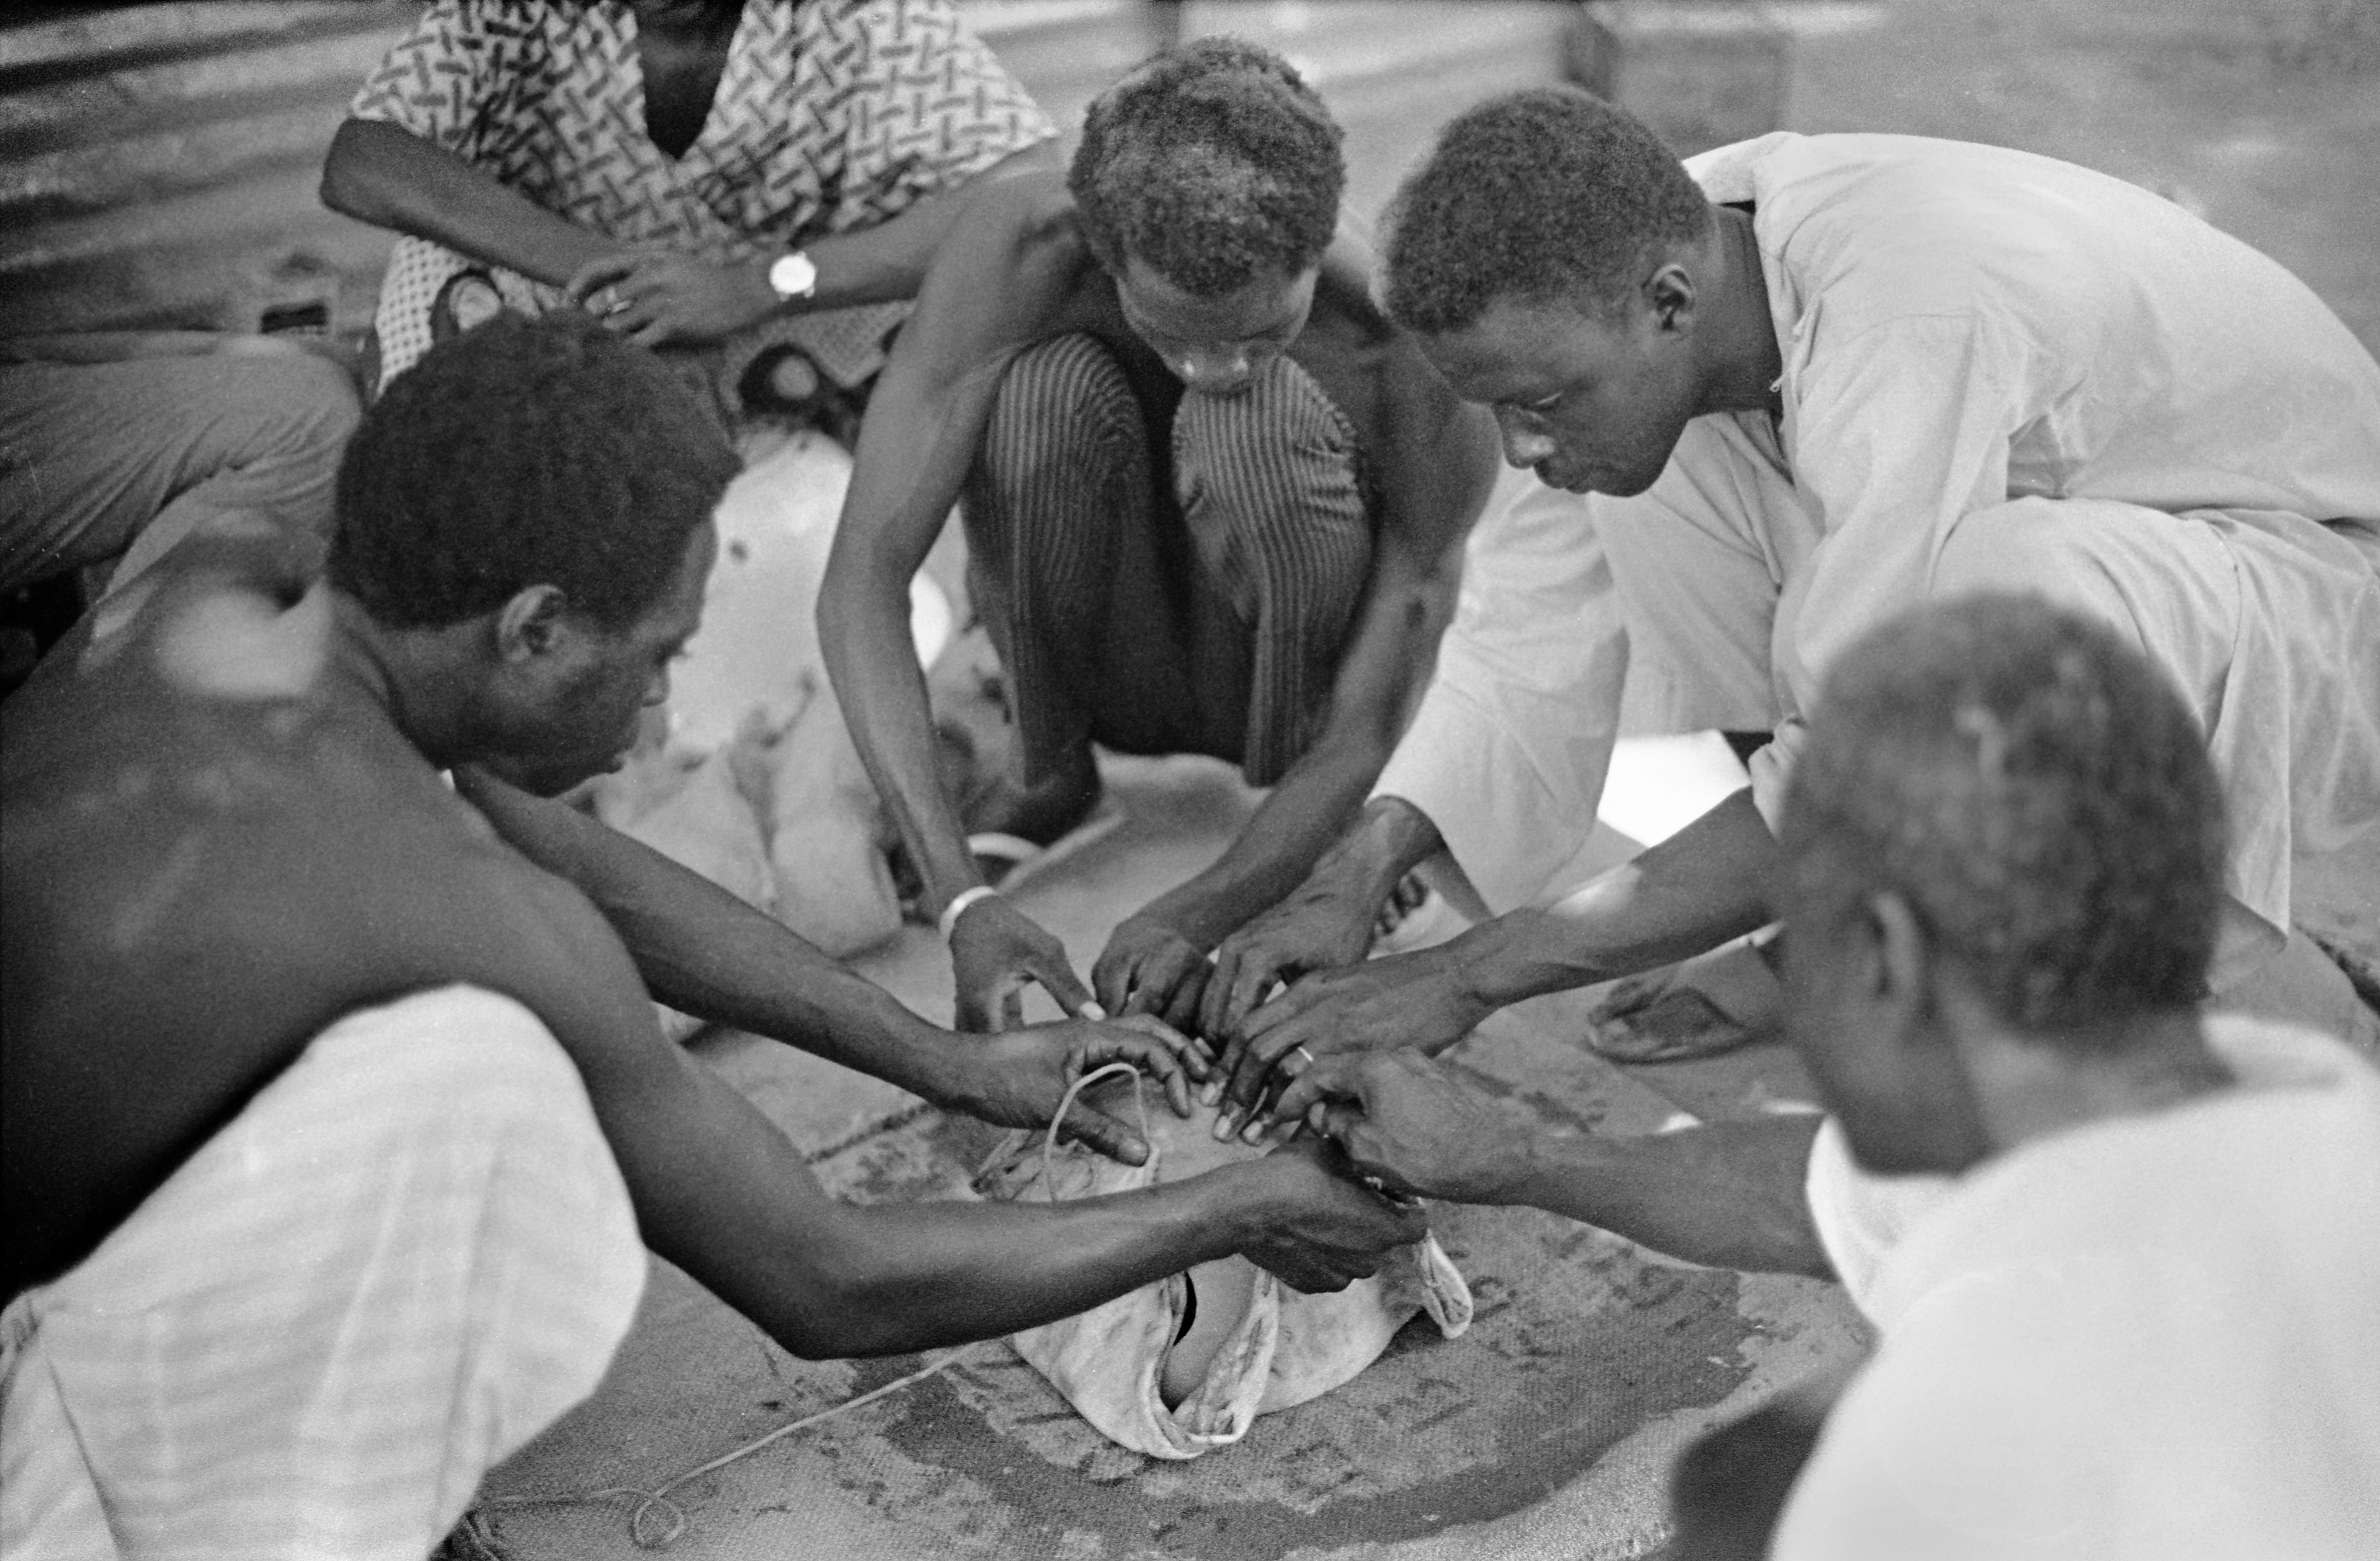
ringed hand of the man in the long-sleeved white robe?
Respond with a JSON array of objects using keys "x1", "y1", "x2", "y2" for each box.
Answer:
[{"x1": 1221, "y1": 945, "x2": 1495, "y2": 1133}]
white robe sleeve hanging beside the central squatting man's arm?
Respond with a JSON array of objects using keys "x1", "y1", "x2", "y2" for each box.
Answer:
[{"x1": 1371, "y1": 478, "x2": 1628, "y2": 914}]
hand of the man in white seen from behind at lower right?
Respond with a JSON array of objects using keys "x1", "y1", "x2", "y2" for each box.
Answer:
[{"x1": 1273, "y1": 1052, "x2": 1528, "y2": 1204}]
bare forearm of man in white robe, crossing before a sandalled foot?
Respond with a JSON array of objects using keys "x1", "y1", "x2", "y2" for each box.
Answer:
[{"x1": 1445, "y1": 790, "x2": 1775, "y2": 1009}]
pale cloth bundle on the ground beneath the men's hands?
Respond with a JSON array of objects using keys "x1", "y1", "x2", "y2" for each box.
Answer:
[{"x1": 976, "y1": 1064, "x2": 1471, "y2": 1459}]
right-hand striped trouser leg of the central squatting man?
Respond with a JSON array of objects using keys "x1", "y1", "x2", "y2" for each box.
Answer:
[{"x1": 1173, "y1": 357, "x2": 1373, "y2": 785}]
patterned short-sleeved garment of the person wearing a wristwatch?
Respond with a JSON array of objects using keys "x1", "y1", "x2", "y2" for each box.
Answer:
[{"x1": 347, "y1": 0, "x2": 1057, "y2": 385}]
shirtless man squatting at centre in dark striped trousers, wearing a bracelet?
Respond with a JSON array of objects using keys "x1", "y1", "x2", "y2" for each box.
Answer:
[{"x1": 819, "y1": 38, "x2": 1495, "y2": 1030}]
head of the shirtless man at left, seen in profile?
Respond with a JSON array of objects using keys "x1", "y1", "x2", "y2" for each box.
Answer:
[{"x1": 328, "y1": 312, "x2": 735, "y2": 792}]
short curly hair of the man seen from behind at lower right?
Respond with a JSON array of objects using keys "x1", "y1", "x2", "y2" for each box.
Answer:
[{"x1": 1780, "y1": 593, "x2": 2225, "y2": 1040}]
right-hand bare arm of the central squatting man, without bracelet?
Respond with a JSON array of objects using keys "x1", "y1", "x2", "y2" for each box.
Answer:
[{"x1": 1092, "y1": 272, "x2": 1497, "y2": 1026}]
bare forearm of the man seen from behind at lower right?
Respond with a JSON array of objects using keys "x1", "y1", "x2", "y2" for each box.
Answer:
[{"x1": 1497, "y1": 1116, "x2": 1833, "y2": 1278}]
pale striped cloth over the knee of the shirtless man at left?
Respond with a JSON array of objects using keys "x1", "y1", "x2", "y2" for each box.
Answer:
[{"x1": 0, "y1": 988, "x2": 645, "y2": 1561}]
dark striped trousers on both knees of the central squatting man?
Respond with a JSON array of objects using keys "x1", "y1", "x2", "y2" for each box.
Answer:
[{"x1": 962, "y1": 336, "x2": 1380, "y2": 785}]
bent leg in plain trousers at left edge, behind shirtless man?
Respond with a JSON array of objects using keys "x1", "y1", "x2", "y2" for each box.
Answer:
[{"x1": 0, "y1": 343, "x2": 359, "y2": 590}]
